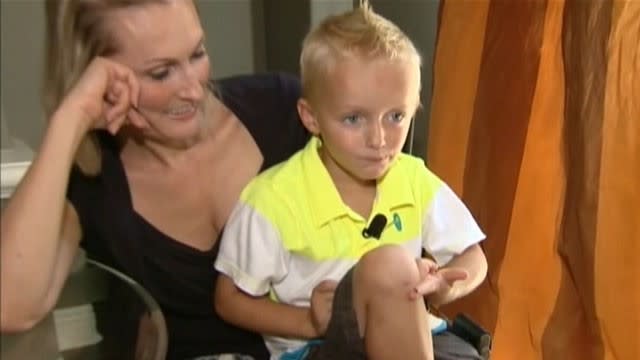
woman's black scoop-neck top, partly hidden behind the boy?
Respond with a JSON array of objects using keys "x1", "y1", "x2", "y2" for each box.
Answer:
[{"x1": 67, "y1": 74, "x2": 309, "y2": 359}]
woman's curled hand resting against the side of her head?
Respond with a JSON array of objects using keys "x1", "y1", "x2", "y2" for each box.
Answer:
[{"x1": 56, "y1": 57, "x2": 146, "y2": 134}]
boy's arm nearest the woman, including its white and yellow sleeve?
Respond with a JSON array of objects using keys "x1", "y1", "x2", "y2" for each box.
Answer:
[{"x1": 214, "y1": 186, "x2": 318, "y2": 338}]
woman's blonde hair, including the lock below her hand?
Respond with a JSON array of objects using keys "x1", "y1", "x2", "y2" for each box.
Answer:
[{"x1": 42, "y1": 0, "x2": 166, "y2": 175}]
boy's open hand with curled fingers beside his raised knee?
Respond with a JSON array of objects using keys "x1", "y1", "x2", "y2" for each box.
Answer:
[{"x1": 409, "y1": 259, "x2": 469, "y2": 303}]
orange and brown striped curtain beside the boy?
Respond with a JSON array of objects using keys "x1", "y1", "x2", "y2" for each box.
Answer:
[{"x1": 427, "y1": 0, "x2": 640, "y2": 360}]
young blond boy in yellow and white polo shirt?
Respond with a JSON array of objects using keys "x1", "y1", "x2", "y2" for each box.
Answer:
[{"x1": 215, "y1": 5, "x2": 486, "y2": 359}]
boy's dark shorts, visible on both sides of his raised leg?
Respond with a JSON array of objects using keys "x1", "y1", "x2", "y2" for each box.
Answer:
[{"x1": 306, "y1": 269, "x2": 482, "y2": 360}]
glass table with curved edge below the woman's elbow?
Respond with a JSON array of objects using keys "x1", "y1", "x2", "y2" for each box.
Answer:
[{"x1": 0, "y1": 253, "x2": 168, "y2": 360}]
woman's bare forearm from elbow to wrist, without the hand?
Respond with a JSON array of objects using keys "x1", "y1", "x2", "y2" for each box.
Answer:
[{"x1": 0, "y1": 114, "x2": 84, "y2": 332}]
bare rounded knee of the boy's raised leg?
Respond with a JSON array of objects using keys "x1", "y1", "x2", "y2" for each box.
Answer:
[{"x1": 354, "y1": 245, "x2": 420, "y2": 294}]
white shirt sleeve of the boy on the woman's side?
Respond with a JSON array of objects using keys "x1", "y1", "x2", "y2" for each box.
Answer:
[{"x1": 215, "y1": 185, "x2": 289, "y2": 296}]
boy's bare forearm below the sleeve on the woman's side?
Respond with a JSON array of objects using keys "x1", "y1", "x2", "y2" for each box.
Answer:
[{"x1": 214, "y1": 274, "x2": 319, "y2": 339}]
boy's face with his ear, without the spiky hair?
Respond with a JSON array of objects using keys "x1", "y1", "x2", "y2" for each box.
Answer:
[{"x1": 299, "y1": 58, "x2": 420, "y2": 183}]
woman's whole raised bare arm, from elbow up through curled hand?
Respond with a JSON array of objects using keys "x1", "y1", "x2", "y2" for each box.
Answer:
[{"x1": 0, "y1": 58, "x2": 139, "y2": 331}]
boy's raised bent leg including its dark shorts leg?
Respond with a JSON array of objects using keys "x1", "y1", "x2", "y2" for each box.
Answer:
[{"x1": 309, "y1": 246, "x2": 433, "y2": 360}]
